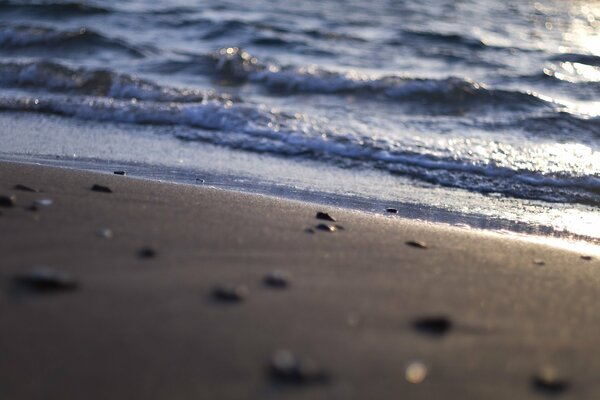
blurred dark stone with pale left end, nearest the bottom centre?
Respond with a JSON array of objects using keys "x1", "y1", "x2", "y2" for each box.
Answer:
[{"x1": 271, "y1": 350, "x2": 329, "y2": 385}]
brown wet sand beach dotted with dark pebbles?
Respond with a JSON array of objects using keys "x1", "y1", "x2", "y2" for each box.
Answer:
[{"x1": 0, "y1": 163, "x2": 600, "y2": 400}]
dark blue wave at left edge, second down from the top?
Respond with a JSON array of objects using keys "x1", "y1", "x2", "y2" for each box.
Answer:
[{"x1": 0, "y1": 25, "x2": 146, "y2": 57}]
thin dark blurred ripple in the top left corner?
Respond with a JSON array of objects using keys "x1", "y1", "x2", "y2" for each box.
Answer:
[{"x1": 0, "y1": 1, "x2": 112, "y2": 17}]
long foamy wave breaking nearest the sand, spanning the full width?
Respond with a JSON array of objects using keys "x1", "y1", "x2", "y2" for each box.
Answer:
[{"x1": 0, "y1": 92, "x2": 600, "y2": 207}]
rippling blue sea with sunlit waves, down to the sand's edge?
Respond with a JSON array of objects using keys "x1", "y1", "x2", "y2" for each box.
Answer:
[{"x1": 0, "y1": 0, "x2": 600, "y2": 240}]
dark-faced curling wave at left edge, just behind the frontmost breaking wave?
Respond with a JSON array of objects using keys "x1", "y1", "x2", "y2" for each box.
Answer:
[{"x1": 0, "y1": 61, "x2": 229, "y2": 103}]
